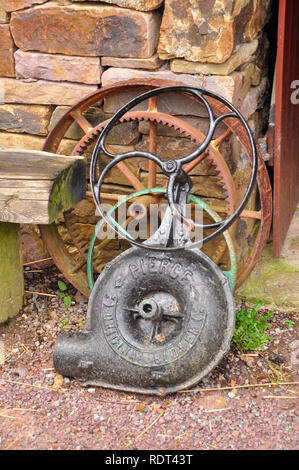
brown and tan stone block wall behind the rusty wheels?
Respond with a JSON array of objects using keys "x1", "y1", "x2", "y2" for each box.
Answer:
[{"x1": 0, "y1": 0, "x2": 271, "y2": 268}]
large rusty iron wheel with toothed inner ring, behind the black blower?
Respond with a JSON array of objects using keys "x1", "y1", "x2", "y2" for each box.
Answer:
[{"x1": 40, "y1": 80, "x2": 271, "y2": 295}]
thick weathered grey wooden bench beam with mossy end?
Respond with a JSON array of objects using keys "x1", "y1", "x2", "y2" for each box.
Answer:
[{"x1": 0, "y1": 149, "x2": 86, "y2": 224}]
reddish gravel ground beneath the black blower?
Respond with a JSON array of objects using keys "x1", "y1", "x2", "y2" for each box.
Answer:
[{"x1": 0, "y1": 266, "x2": 299, "y2": 450}]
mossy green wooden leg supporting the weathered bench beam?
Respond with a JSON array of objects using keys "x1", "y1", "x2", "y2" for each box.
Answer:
[{"x1": 0, "y1": 222, "x2": 24, "y2": 323}]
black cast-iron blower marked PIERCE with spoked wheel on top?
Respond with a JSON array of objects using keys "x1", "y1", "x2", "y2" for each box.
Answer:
[{"x1": 54, "y1": 86, "x2": 258, "y2": 395}]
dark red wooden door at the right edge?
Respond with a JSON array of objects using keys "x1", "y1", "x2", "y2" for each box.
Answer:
[{"x1": 273, "y1": 0, "x2": 299, "y2": 257}]
